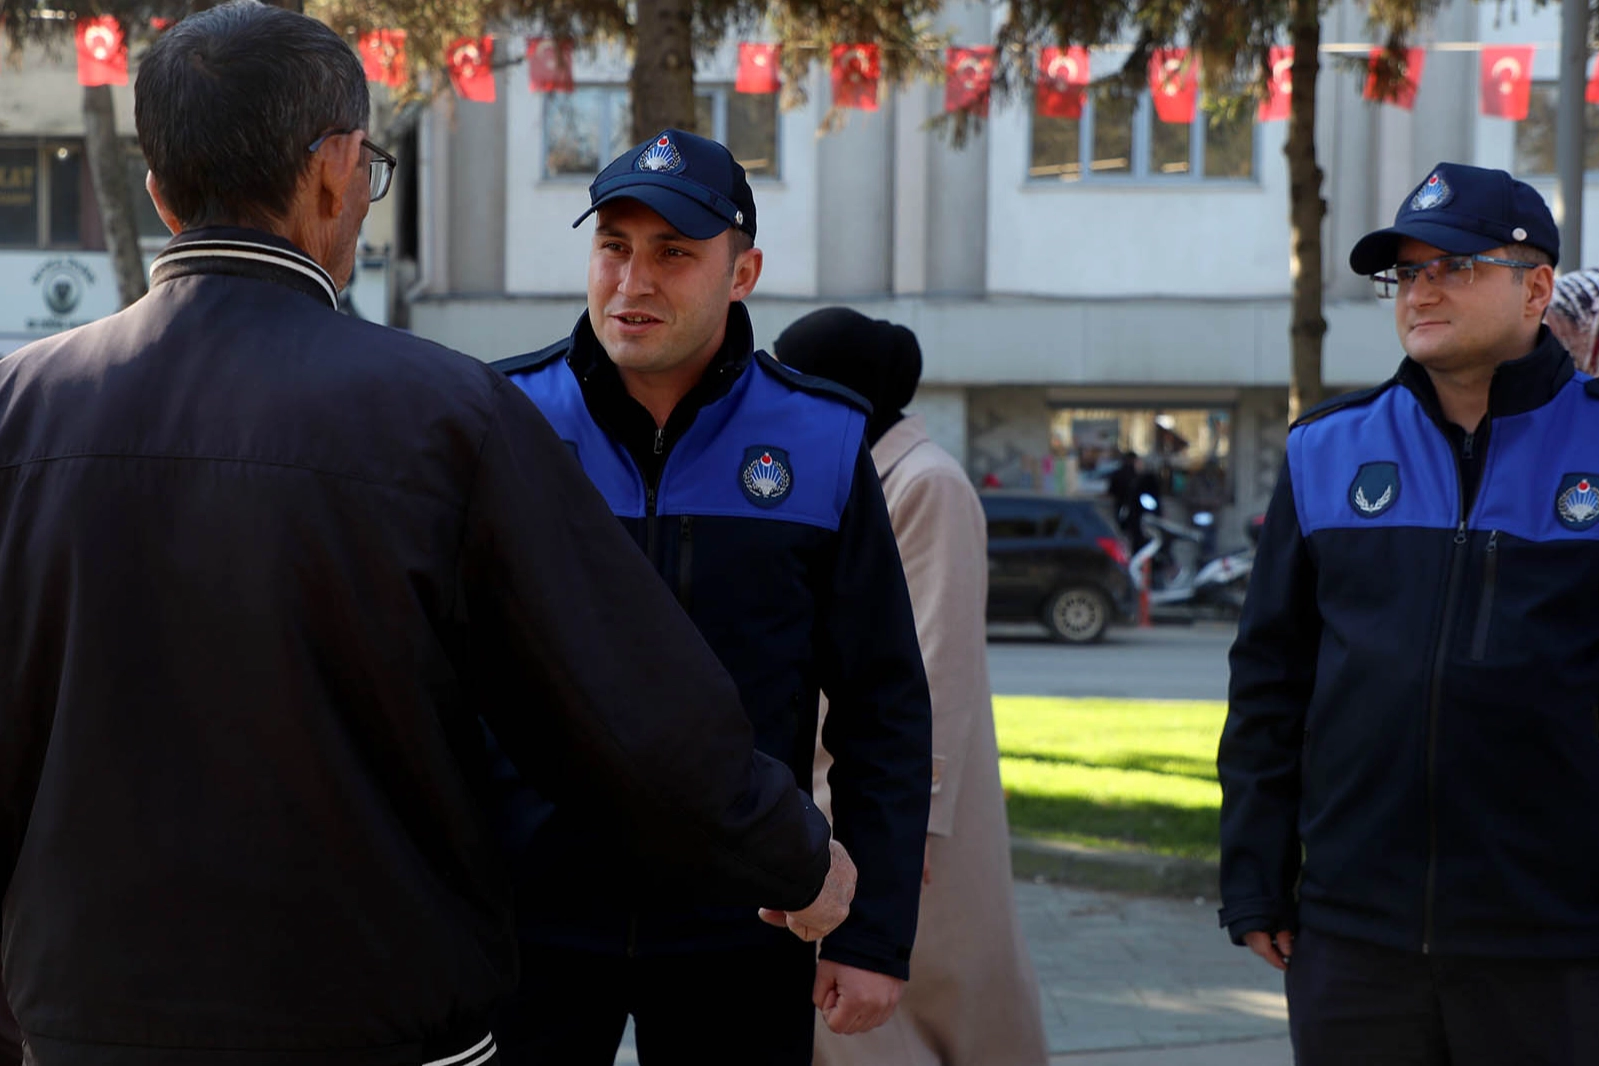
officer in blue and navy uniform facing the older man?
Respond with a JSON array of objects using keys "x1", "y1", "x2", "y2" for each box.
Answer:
[{"x1": 496, "y1": 129, "x2": 931, "y2": 1066}]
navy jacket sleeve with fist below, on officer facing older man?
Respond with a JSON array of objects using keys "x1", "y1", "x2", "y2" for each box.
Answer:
[{"x1": 817, "y1": 447, "x2": 932, "y2": 978}]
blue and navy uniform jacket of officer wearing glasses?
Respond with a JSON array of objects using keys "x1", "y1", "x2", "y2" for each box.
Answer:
[{"x1": 1218, "y1": 331, "x2": 1599, "y2": 957}]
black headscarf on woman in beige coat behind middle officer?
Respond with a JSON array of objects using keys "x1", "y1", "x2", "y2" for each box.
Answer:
[{"x1": 776, "y1": 307, "x2": 921, "y2": 444}]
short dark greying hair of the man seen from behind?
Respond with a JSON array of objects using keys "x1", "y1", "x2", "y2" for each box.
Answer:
[{"x1": 133, "y1": 0, "x2": 371, "y2": 229}]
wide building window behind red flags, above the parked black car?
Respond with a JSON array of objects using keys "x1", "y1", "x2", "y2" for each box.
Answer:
[{"x1": 1028, "y1": 93, "x2": 1255, "y2": 182}]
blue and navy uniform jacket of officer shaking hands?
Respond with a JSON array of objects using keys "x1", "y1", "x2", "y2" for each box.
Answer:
[{"x1": 496, "y1": 304, "x2": 932, "y2": 978}]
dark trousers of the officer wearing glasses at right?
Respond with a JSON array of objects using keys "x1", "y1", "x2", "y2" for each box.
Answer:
[{"x1": 1286, "y1": 929, "x2": 1599, "y2": 1066}]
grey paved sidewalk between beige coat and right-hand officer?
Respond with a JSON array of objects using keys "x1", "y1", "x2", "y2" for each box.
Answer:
[{"x1": 616, "y1": 881, "x2": 1294, "y2": 1066}]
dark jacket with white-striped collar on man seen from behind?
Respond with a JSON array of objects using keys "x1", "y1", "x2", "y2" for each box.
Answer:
[{"x1": 0, "y1": 230, "x2": 828, "y2": 1066}]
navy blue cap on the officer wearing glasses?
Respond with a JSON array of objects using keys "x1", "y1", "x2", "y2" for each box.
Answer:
[{"x1": 1350, "y1": 163, "x2": 1561, "y2": 273}]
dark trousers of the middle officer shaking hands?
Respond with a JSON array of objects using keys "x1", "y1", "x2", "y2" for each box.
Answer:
[{"x1": 494, "y1": 940, "x2": 815, "y2": 1066}]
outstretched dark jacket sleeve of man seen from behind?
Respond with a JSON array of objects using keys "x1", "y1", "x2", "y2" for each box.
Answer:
[{"x1": 461, "y1": 377, "x2": 830, "y2": 909}]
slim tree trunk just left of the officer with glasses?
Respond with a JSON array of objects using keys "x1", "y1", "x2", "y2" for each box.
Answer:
[{"x1": 1282, "y1": 0, "x2": 1327, "y2": 422}]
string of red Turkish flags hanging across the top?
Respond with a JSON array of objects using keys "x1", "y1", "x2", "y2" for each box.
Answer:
[{"x1": 43, "y1": 14, "x2": 1579, "y2": 123}]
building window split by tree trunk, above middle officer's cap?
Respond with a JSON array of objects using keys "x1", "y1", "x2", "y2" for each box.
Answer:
[{"x1": 544, "y1": 85, "x2": 779, "y2": 179}]
